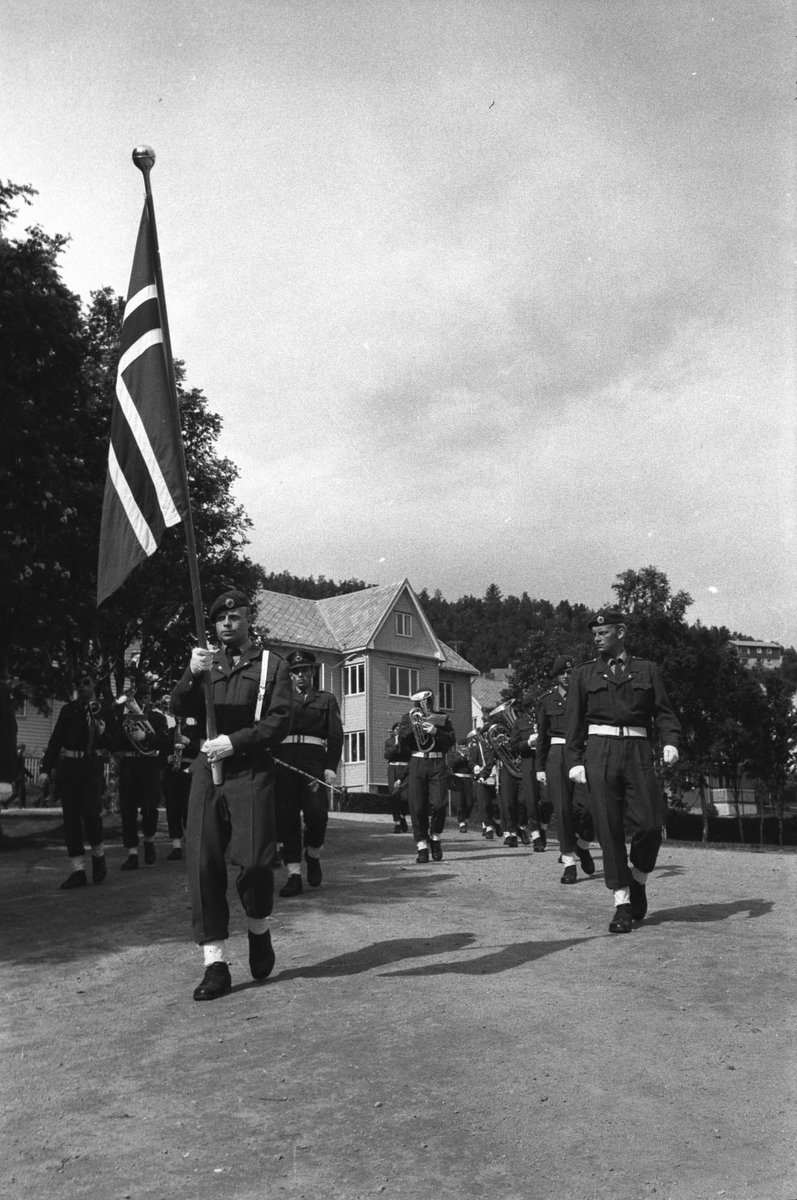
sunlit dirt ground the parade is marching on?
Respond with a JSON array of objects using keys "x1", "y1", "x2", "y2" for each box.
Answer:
[{"x1": 0, "y1": 816, "x2": 797, "y2": 1200}]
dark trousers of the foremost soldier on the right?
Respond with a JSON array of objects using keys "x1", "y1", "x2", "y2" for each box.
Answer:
[{"x1": 583, "y1": 734, "x2": 666, "y2": 890}]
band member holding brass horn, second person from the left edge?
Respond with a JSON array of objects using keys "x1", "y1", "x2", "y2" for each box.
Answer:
[{"x1": 116, "y1": 679, "x2": 170, "y2": 871}]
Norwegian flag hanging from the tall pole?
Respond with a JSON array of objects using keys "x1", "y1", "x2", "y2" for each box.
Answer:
[{"x1": 97, "y1": 204, "x2": 188, "y2": 605}]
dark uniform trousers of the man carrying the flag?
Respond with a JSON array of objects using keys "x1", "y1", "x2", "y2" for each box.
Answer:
[{"x1": 186, "y1": 755, "x2": 276, "y2": 943}]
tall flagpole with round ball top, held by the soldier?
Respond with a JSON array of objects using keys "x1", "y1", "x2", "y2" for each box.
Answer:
[{"x1": 133, "y1": 145, "x2": 224, "y2": 784}]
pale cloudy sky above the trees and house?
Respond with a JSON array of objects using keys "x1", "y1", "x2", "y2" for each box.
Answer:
[{"x1": 0, "y1": 0, "x2": 797, "y2": 646}]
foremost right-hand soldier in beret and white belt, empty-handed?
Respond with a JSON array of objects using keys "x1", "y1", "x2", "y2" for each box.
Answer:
[{"x1": 565, "y1": 608, "x2": 681, "y2": 934}]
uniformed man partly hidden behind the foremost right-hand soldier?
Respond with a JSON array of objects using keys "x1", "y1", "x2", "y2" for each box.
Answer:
[{"x1": 537, "y1": 654, "x2": 595, "y2": 883}]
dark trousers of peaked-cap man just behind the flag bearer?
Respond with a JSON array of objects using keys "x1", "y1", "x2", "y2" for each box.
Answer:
[{"x1": 276, "y1": 743, "x2": 329, "y2": 863}]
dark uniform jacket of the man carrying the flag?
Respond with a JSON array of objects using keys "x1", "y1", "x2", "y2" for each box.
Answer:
[{"x1": 172, "y1": 642, "x2": 293, "y2": 770}]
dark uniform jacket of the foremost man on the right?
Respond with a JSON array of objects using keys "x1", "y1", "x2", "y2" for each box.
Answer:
[{"x1": 565, "y1": 655, "x2": 681, "y2": 768}]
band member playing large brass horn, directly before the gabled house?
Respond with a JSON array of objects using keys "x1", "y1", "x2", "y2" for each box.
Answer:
[{"x1": 399, "y1": 690, "x2": 456, "y2": 863}]
